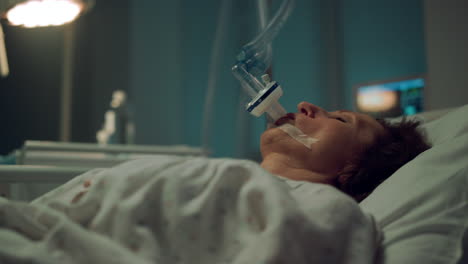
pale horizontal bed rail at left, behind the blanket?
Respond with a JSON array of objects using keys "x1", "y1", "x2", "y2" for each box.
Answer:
[{"x1": 0, "y1": 140, "x2": 208, "y2": 201}]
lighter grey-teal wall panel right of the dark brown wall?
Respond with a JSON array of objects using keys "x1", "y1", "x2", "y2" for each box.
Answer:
[{"x1": 129, "y1": 1, "x2": 184, "y2": 144}]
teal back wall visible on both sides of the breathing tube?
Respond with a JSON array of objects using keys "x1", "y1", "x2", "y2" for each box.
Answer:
[{"x1": 129, "y1": 0, "x2": 426, "y2": 160}]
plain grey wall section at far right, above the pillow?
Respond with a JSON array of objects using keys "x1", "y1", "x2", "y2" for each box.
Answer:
[{"x1": 424, "y1": 0, "x2": 468, "y2": 109}]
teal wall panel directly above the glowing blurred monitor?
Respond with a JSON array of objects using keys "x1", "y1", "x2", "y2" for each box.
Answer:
[{"x1": 340, "y1": 0, "x2": 426, "y2": 109}]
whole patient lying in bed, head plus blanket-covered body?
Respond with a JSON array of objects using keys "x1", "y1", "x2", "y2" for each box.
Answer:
[{"x1": 0, "y1": 102, "x2": 436, "y2": 264}]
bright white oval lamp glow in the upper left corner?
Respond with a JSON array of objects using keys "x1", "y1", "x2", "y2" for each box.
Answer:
[{"x1": 6, "y1": 0, "x2": 82, "y2": 28}]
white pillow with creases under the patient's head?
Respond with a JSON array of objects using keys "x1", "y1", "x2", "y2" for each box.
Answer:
[{"x1": 361, "y1": 105, "x2": 468, "y2": 264}]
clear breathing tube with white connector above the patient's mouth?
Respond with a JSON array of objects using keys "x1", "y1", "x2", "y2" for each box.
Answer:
[{"x1": 232, "y1": 0, "x2": 294, "y2": 121}]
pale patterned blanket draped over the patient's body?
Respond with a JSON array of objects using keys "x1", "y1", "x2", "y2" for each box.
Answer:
[{"x1": 0, "y1": 156, "x2": 381, "y2": 264}]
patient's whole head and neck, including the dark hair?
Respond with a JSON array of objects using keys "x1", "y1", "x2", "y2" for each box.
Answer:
[{"x1": 260, "y1": 102, "x2": 430, "y2": 201}]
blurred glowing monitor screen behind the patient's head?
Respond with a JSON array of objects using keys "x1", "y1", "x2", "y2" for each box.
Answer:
[{"x1": 353, "y1": 75, "x2": 426, "y2": 118}]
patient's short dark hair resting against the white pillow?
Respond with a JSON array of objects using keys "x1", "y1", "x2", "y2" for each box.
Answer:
[{"x1": 337, "y1": 119, "x2": 431, "y2": 202}]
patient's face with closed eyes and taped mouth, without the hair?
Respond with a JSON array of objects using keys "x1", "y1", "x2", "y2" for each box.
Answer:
[{"x1": 260, "y1": 102, "x2": 385, "y2": 182}]
